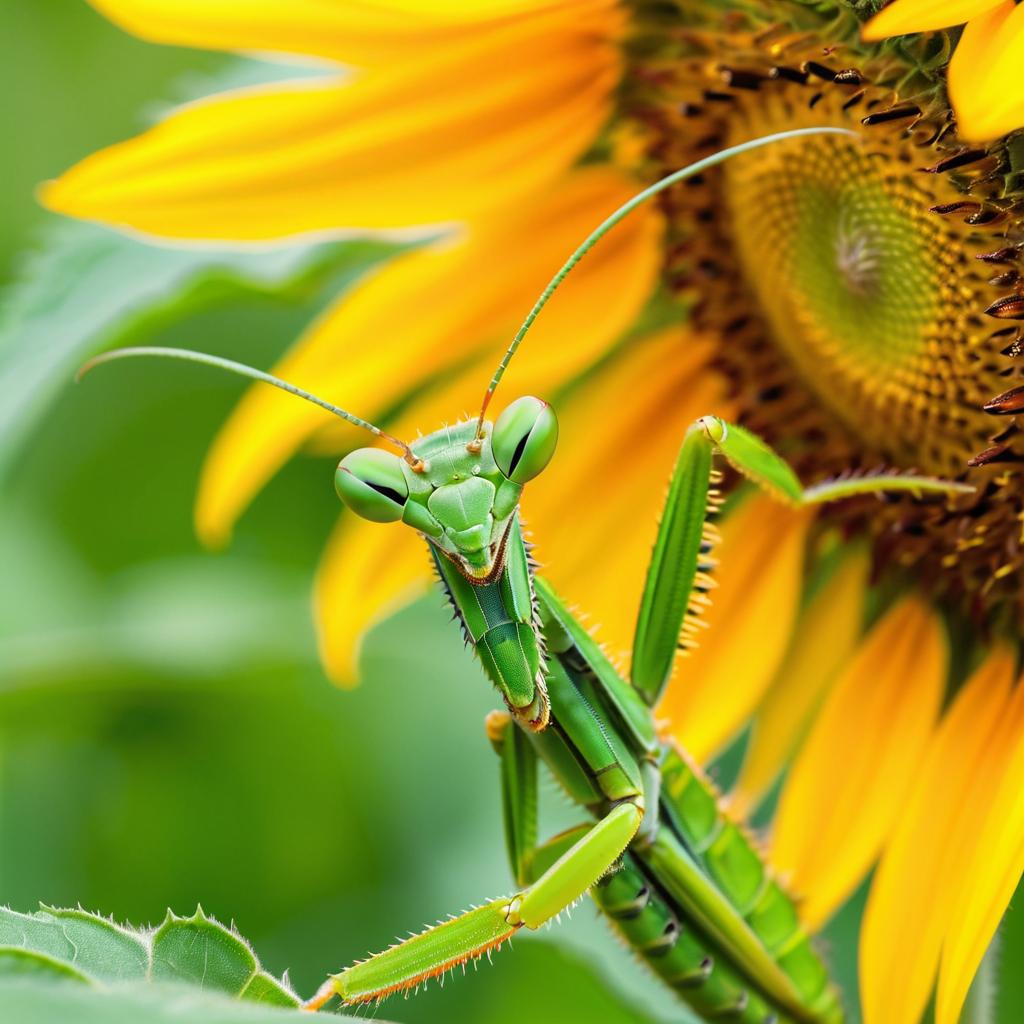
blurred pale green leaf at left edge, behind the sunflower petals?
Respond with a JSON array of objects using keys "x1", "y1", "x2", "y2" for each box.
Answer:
[{"x1": 0, "y1": 222, "x2": 399, "y2": 475}]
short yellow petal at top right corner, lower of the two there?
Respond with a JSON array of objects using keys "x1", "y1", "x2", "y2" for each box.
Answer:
[{"x1": 949, "y1": 0, "x2": 1024, "y2": 142}]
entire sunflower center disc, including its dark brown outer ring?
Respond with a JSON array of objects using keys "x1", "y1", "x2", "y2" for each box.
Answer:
[{"x1": 622, "y1": 0, "x2": 1024, "y2": 623}]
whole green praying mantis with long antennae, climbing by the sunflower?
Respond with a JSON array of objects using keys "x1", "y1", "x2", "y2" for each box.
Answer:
[{"x1": 75, "y1": 128, "x2": 972, "y2": 1024}]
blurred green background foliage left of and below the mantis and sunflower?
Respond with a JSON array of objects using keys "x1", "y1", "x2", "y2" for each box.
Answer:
[{"x1": 0, "y1": 0, "x2": 880, "y2": 1024}]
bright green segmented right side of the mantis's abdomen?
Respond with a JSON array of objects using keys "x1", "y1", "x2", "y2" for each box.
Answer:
[{"x1": 662, "y1": 743, "x2": 843, "y2": 1022}]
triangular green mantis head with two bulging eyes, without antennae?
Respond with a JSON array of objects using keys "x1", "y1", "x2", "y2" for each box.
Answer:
[{"x1": 335, "y1": 396, "x2": 558, "y2": 584}]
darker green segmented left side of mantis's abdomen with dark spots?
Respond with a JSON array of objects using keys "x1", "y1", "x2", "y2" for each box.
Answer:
[{"x1": 591, "y1": 856, "x2": 794, "y2": 1024}]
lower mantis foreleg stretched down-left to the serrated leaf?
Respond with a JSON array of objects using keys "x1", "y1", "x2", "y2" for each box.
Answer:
[{"x1": 323, "y1": 801, "x2": 643, "y2": 1009}]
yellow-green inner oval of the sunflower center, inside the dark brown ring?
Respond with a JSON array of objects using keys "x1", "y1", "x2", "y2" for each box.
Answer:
[{"x1": 723, "y1": 91, "x2": 974, "y2": 473}]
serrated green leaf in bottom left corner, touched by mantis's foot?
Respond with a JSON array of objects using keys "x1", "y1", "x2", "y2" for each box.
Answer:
[{"x1": 0, "y1": 907, "x2": 380, "y2": 1022}]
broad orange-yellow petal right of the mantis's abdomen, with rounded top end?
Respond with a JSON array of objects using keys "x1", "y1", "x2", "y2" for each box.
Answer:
[{"x1": 772, "y1": 597, "x2": 948, "y2": 928}]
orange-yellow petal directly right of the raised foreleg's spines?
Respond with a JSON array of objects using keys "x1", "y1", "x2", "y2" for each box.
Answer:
[{"x1": 658, "y1": 494, "x2": 812, "y2": 761}]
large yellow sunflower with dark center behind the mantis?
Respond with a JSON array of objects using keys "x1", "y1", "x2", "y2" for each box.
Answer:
[{"x1": 43, "y1": 0, "x2": 1024, "y2": 1024}]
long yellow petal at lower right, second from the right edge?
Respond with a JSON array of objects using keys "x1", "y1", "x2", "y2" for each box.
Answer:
[{"x1": 860, "y1": 647, "x2": 1014, "y2": 1024}]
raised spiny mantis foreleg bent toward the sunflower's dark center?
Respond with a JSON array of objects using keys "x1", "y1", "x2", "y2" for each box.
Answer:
[{"x1": 631, "y1": 416, "x2": 974, "y2": 707}]
